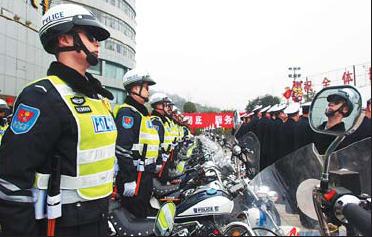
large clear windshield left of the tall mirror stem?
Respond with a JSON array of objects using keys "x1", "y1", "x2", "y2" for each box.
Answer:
[{"x1": 214, "y1": 144, "x2": 322, "y2": 236}]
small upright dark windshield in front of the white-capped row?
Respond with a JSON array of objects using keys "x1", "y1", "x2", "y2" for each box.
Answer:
[{"x1": 238, "y1": 132, "x2": 260, "y2": 179}]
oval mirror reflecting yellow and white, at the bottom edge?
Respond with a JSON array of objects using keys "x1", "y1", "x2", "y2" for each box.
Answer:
[{"x1": 154, "y1": 202, "x2": 176, "y2": 236}]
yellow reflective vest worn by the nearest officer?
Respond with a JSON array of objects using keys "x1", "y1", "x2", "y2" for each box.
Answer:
[{"x1": 35, "y1": 76, "x2": 117, "y2": 200}]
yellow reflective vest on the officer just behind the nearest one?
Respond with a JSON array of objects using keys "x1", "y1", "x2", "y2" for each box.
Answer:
[{"x1": 114, "y1": 104, "x2": 160, "y2": 166}]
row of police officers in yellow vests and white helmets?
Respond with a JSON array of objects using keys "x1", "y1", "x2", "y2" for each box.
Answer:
[{"x1": 0, "y1": 4, "x2": 192, "y2": 236}]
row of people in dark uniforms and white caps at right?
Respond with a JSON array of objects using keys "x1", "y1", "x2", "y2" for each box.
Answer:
[{"x1": 233, "y1": 92, "x2": 372, "y2": 169}]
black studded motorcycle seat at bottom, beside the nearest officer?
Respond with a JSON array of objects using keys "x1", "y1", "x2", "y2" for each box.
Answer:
[{"x1": 108, "y1": 201, "x2": 154, "y2": 236}]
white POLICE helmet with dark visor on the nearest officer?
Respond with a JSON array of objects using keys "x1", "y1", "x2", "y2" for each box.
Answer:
[{"x1": 39, "y1": 4, "x2": 110, "y2": 65}]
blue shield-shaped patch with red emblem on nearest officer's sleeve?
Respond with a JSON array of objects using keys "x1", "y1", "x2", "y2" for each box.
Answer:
[{"x1": 10, "y1": 103, "x2": 40, "y2": 134}]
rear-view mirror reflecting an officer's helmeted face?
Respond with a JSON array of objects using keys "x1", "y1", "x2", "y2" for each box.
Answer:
[{"x1": 310, "y1": 85, "x2": 362, "y2": 136}]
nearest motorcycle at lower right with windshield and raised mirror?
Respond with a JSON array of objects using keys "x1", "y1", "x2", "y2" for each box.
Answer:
[{"x1": 211, "y1": 86, "x2": 372, "y2": 236}]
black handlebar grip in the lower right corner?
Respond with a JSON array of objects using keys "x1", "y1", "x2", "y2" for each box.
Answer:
[{"x1": 342, "y1": 203, "x2": 372, "y2": 236}]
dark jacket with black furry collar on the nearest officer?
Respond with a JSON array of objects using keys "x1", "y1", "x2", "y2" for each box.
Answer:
[{"x1": 0, "y1": 62, "x2": 116, "y2": 235}]
